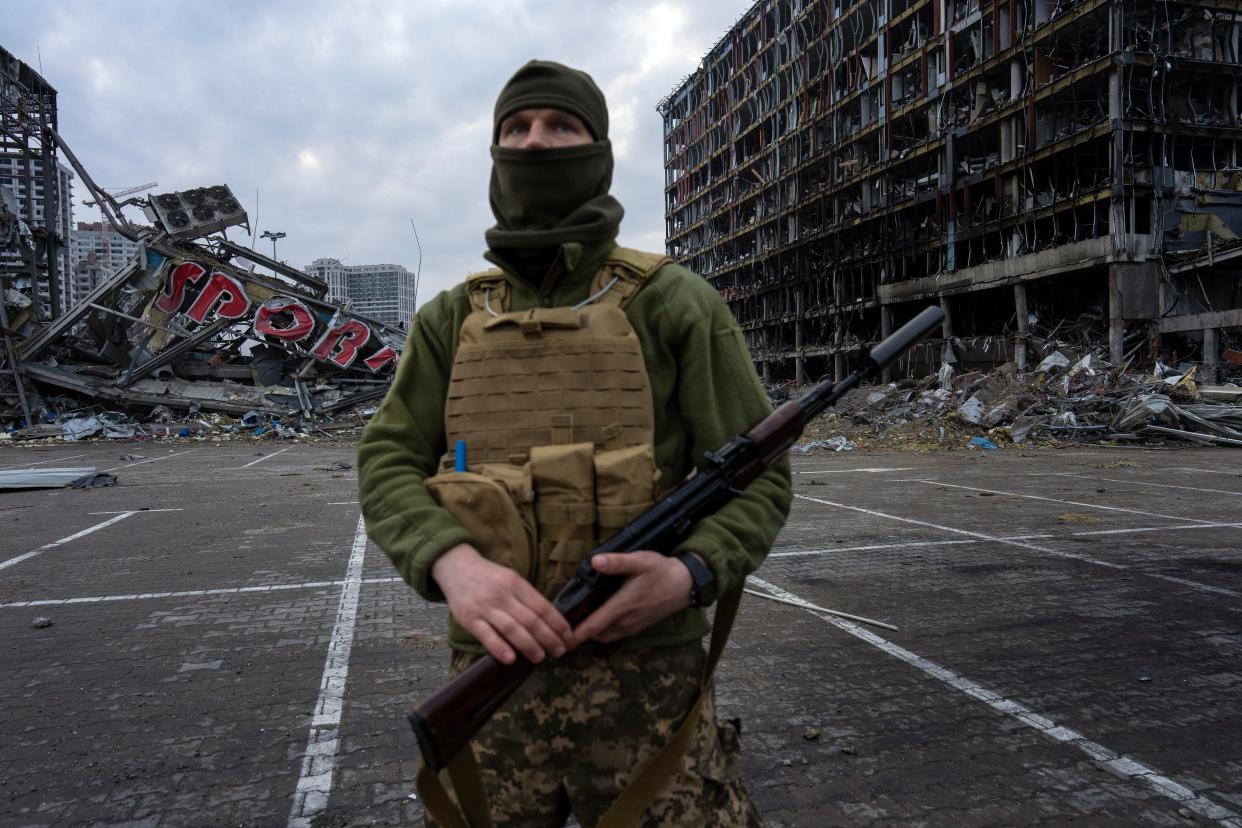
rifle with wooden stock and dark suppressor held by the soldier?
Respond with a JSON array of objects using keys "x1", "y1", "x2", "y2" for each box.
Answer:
[{"x1": 409, "y1": 307, "x2": 944, "y2": 772}]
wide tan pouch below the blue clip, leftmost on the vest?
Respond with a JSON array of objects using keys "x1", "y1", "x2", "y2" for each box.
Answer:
[{"x1": 424, "y1": 463, "x2": 535, "y2": 578}]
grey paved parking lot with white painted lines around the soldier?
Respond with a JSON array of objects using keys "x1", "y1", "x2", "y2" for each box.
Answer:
[{"x1": 0, "y1": 443, "x2": 1242, "y2": 828}]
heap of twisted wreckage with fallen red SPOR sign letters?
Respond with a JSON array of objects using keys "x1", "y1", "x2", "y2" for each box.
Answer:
[{"x1": 0, "y1": 176, "x2": 405, "y2": 441}]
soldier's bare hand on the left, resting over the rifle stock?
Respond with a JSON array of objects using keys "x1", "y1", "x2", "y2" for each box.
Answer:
[{"x1": 431, "y1": 544, "x2": 571, "y2": 664}]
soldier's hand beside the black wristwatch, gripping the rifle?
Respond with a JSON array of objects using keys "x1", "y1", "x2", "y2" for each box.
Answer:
[{"x1": 574, "y1": 551, "x2": 692, "y2": 646}]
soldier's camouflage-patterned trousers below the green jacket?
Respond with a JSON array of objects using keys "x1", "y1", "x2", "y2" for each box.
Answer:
[{"x1": 427, "y1": 642, "x2": 763, "y2": 828}]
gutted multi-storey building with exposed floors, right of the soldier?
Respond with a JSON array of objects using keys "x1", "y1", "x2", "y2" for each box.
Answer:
[{"x1": 658, "y1": 0, "x2": 1242, "y2": 382}]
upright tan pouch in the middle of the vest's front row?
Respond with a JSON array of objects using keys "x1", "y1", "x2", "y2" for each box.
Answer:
[{"x1": 530, "y1": 443, "x2": 595, "y2": 597}]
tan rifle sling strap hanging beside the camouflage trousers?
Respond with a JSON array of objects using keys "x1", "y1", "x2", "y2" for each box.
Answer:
[{"x1": 416, "y1": 583, "x2": 743, "y2": 828}]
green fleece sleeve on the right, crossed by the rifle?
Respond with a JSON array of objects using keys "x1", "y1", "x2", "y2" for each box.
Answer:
[{"x1": 676, "y1": 272, "x2": 792, "y2": 592}]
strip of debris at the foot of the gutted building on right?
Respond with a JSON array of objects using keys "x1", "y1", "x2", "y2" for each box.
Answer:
[{"x1": 789, "y1": 349, "x2": 1242, "y2": 452}]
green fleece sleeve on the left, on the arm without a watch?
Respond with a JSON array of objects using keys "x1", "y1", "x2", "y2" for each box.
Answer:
[{"x1": 358, "y1": 293, "x2": 473, "y2": 601}]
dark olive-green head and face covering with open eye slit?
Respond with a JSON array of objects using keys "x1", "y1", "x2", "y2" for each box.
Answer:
[{"x1": 484, "y1": 61, "x2": 625, "y2": 254}]
